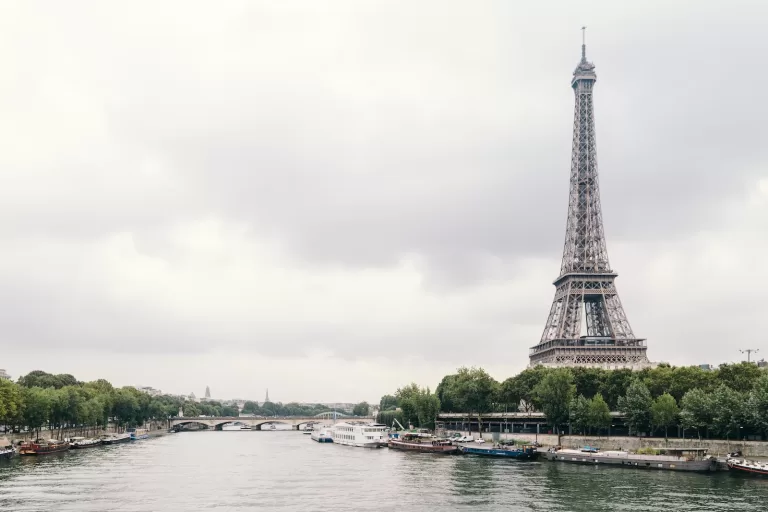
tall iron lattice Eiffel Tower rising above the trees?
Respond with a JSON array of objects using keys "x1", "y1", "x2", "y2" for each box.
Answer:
[{"x1": 530, "y1": 40, "x2": 649, "y2": 368}]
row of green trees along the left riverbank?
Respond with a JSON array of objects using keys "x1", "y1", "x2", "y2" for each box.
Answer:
[{"x1": 0, "y1": 370, "x2": 340, "y2": 437}]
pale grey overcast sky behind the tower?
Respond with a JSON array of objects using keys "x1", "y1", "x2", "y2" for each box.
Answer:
[{"x1": 0, "y1": 0, "x2": 768, "y2": 401}]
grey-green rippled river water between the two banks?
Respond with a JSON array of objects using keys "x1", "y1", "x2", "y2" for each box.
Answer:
[{"x1": 0, "y1": 431, "x2": 768, "y2": 512}]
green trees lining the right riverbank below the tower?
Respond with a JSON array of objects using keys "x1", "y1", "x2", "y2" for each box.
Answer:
[{"x1": 377, "y1": 363, "x2": 768, "y2": 439}]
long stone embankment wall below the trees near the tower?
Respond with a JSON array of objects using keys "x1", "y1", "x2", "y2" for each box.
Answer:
[{"x1": 465, "y1": 432, "x2": 768, "y2": 457}]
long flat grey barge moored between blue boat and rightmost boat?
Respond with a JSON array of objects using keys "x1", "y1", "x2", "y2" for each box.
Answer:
[{"x1": 545, "y1": 447, "x2": 717, "y2": 472}]
